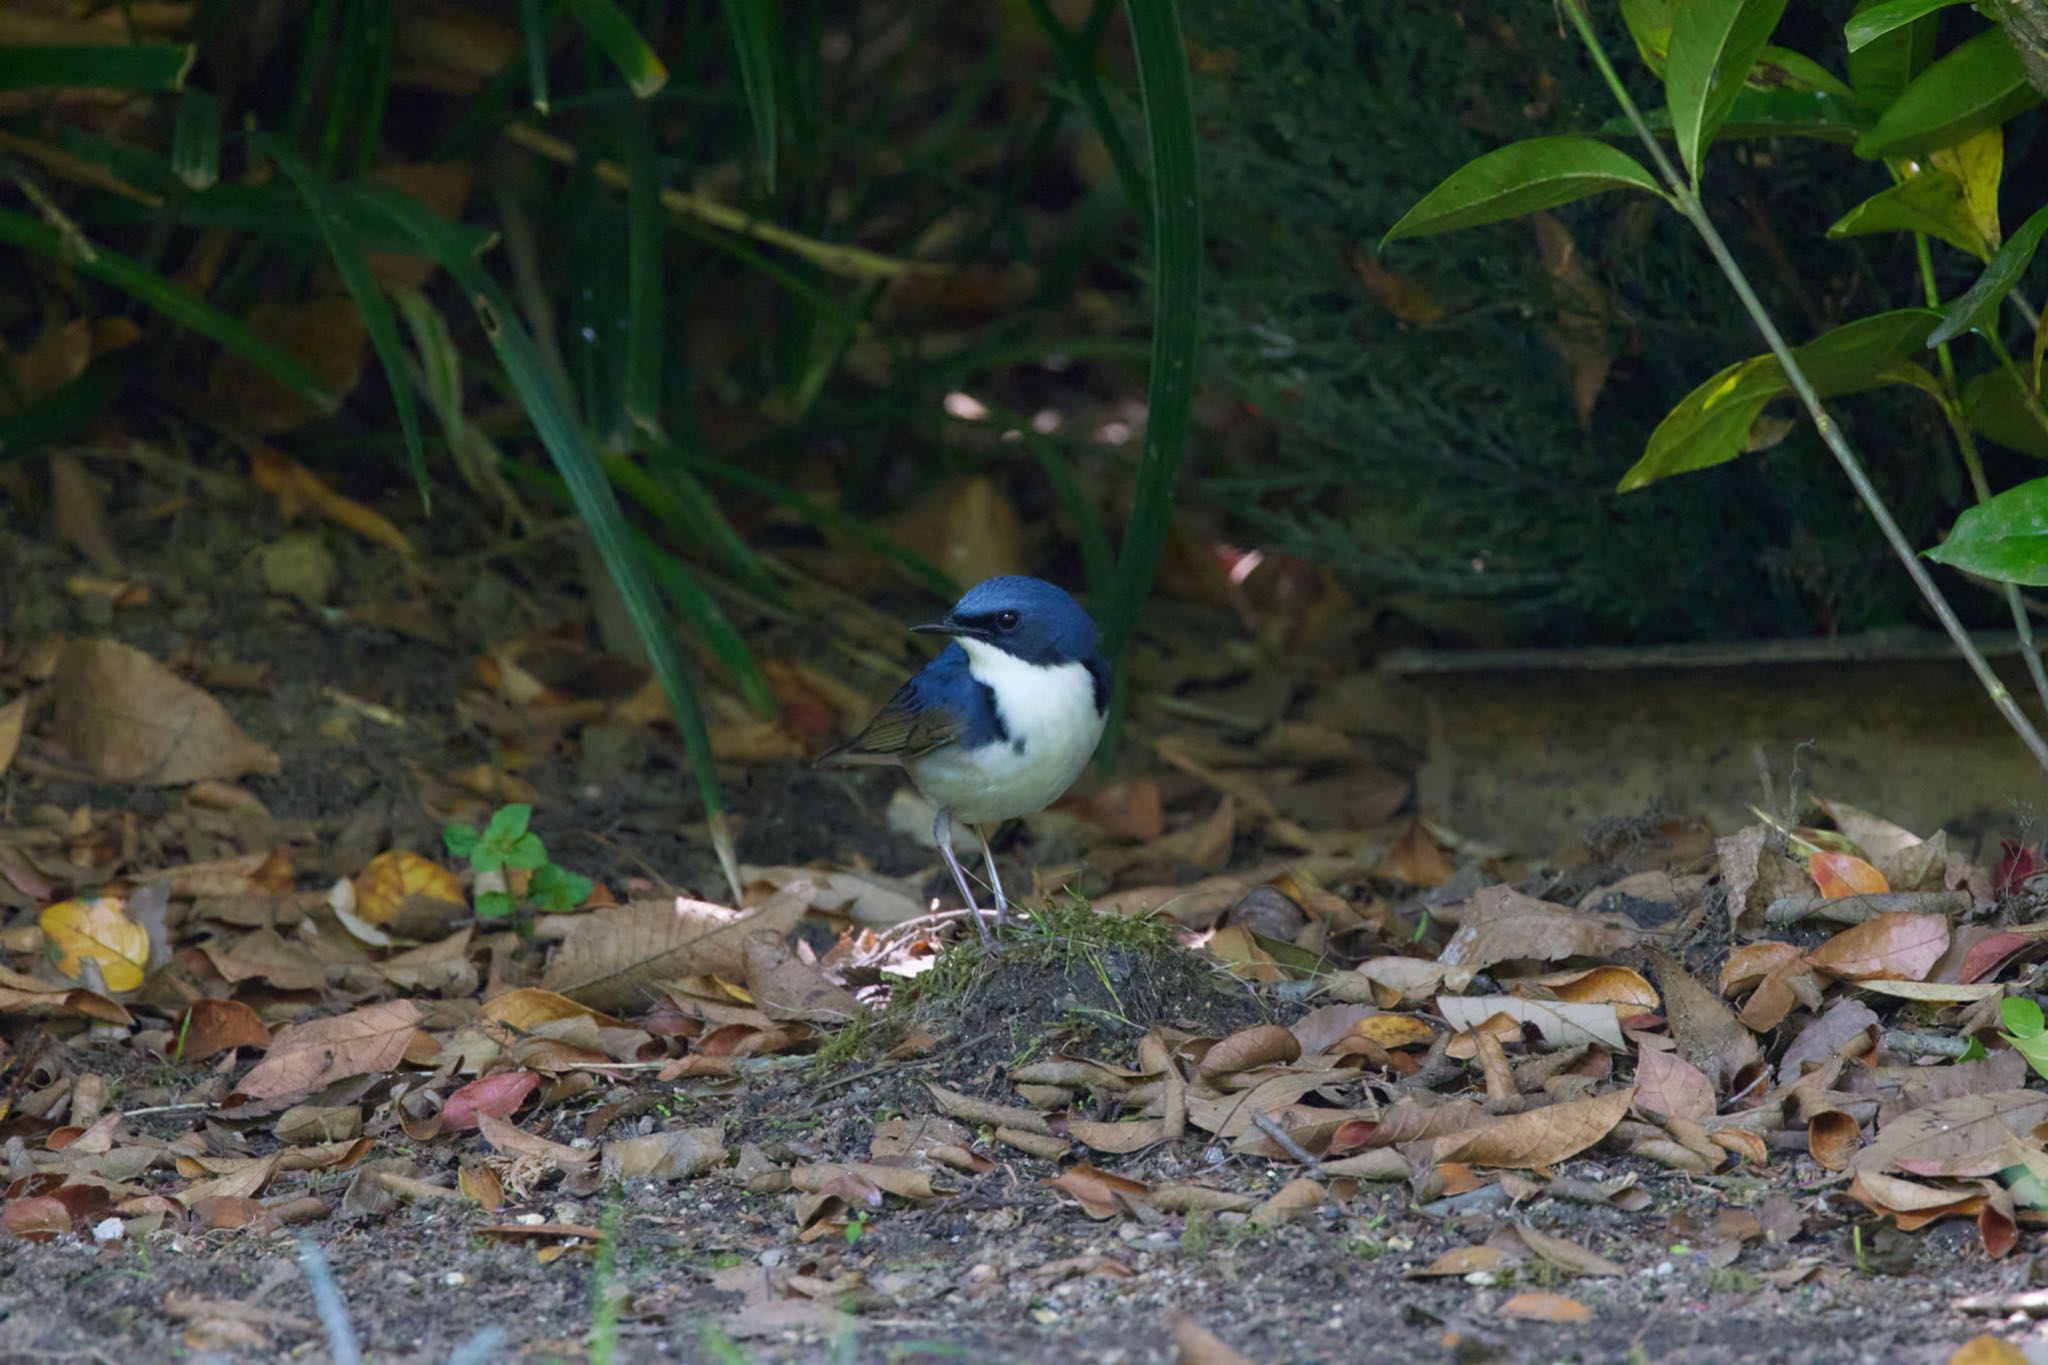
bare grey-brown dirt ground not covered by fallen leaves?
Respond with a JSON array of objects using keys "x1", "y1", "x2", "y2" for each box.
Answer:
[{"x1": 0, "y1": 462, "x2": 2048, "y2": 1365}]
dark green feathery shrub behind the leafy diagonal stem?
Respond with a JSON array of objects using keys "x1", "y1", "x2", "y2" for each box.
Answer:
[{"x1": 1188, "y1": 0, "x2": 2030, "y2": 643}]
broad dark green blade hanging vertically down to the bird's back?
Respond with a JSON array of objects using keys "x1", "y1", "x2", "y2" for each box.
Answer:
[{"x1": 1102, "y1": 0, "x2": 1202, "y2": 659}]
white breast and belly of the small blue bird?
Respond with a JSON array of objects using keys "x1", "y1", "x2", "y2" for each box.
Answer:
[{"x1": 909, "y1": 641, "x2": 1102, "y2": 825}]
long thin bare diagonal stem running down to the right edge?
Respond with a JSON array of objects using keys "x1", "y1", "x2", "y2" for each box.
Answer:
[{"x1": 1565, "y1": 0, "x2": 2048, "y2": 767}]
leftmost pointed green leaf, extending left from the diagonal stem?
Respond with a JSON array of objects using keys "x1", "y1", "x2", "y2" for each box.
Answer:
[{"x1": 1380, "y1": 137, "x2": 1663, "y2": 250}]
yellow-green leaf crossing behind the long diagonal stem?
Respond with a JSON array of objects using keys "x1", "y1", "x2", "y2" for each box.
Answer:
[{"x1": 1620, "y1": 309, "x2": 1942, "y2": 493}]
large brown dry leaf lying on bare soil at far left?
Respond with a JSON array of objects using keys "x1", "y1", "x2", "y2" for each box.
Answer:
[{"x1": 51, "y1": 641, "x2": 281, "y2": 786}]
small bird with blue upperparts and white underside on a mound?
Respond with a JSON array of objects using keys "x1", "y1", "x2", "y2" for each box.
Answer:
[{"x1": 817, "y1": 577, "x2": 1110, "y2": 943}]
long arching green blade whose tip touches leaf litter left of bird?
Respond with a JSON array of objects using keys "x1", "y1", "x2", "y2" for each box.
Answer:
[{"x1": 354, "y1": 184, "x2": 739, "y2": 902}]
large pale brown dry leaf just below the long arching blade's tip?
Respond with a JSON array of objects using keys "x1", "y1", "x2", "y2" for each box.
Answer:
[{"x1": 541, "y1": 886, "x2": 805, "y2": 1009}]
